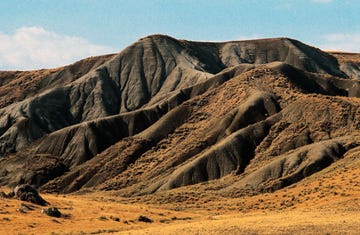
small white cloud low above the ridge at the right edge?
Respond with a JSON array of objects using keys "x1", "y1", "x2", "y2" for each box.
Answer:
[{"x1": 320, "y1": 33, "x2": 360, "y2": 52}]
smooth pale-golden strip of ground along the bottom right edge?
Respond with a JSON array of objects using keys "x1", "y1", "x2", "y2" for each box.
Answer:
[{"x1": 118, "y1": 210, "x2": 360, "y2": 234}]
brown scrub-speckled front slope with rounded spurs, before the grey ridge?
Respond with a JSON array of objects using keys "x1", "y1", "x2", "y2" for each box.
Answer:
[{"x1": 30, "y1": 64, "x2": 359, "y2": 195}]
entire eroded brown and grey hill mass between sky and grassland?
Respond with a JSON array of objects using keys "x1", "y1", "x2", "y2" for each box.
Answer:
[{"x1": 0, "y1": 35, "x2": 360, "y2": 199}]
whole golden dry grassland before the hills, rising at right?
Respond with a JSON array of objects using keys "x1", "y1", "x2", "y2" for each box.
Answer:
[{"x1": 0, "y1": 156, "x2": 360, "y2": 234}]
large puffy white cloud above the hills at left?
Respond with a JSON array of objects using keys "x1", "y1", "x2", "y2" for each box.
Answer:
[{"x1": 0, "y1": 27, "x2": 114, "y2": 70}]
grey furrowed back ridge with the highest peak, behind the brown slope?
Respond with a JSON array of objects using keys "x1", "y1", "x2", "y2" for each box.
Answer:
[{"x1": 0, "y1": 35, "x2": 357, "y2": 154}]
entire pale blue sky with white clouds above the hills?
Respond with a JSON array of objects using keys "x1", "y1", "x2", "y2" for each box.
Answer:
[{"x1": 0, "y1": 0, "x2": 360, "y2": 70}]
